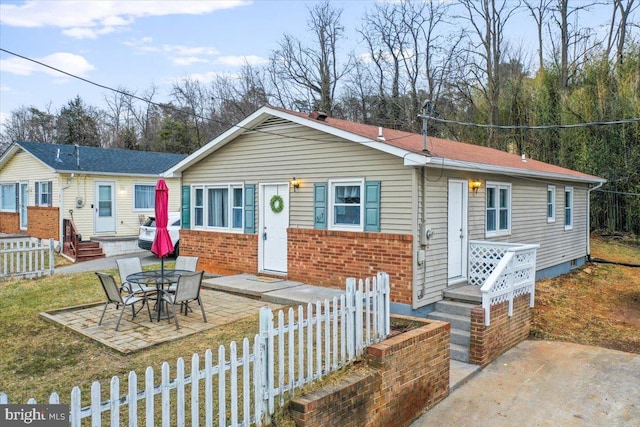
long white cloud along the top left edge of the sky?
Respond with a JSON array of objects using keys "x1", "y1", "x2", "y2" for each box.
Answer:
[{"x1": 0, "y1": 0, "x2": 252, "y2": 38}]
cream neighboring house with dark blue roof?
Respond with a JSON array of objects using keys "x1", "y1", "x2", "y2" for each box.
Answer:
[{"x1": 0, "y1": 142, "x2": 186, "y2": 258}]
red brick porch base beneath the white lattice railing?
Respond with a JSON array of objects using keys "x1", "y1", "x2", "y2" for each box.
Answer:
[{"x1": 469, "y1": 294, "x2": 533, "y2": 366}]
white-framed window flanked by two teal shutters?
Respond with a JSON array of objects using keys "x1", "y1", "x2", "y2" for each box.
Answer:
[{"x1": 329, "y1": 179, "x2": 364, "y2": 231}]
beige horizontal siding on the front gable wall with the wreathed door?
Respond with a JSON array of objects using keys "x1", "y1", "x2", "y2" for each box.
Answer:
[{"x1": 182, "y1": 122, "x2": 413, "y2": 234}]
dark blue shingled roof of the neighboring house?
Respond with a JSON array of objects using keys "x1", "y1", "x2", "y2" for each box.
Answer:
[{"x1": 16, "y1": 142, "x2": 186, "y2": 175}]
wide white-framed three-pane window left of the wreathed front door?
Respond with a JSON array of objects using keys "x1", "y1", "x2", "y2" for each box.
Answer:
[{"x1": 192, "y1": 184, "x2": 244, "y2": 231}]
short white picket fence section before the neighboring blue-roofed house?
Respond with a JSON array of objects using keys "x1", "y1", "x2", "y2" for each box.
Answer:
[{"x1": 0, "y1": 237, "x2": 54, "y2": 278}]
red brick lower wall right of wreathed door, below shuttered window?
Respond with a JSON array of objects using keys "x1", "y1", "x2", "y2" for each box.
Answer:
[{"x1": 287, "y1": 228, "x2": 413, "y2": 304}]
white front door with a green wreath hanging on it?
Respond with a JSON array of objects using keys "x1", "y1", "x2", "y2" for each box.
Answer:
[{"x1": 258, "y1": 183, "x2": 289, "y2": 273}]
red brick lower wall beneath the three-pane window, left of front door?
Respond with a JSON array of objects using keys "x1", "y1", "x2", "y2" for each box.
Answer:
[{"x1": 180, "y1": 230, "x2": 258, "y2": 275}]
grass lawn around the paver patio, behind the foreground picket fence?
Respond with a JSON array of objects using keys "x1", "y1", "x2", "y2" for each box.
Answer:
[{"x1": 0, "y1": 270, "x2": 258, "y2": 403}]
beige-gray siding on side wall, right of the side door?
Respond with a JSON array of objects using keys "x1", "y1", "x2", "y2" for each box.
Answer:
[{"x1": 470, "y1": 175, "x2": 588, "y2": 270}]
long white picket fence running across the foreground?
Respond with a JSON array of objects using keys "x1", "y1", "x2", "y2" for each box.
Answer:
[{"x1": 0, "y1": 273, "x2": 390, "y2": 427}]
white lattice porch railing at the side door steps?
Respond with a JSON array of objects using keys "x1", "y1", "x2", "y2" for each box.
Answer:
[{"x1": 469, "y1": 241, "x2": 540, "y2": 326}]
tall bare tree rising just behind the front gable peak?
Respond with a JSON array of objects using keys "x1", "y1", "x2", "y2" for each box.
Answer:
[{"x1": 270, "y1": 0, "x2": 352, "y2": 115}]
